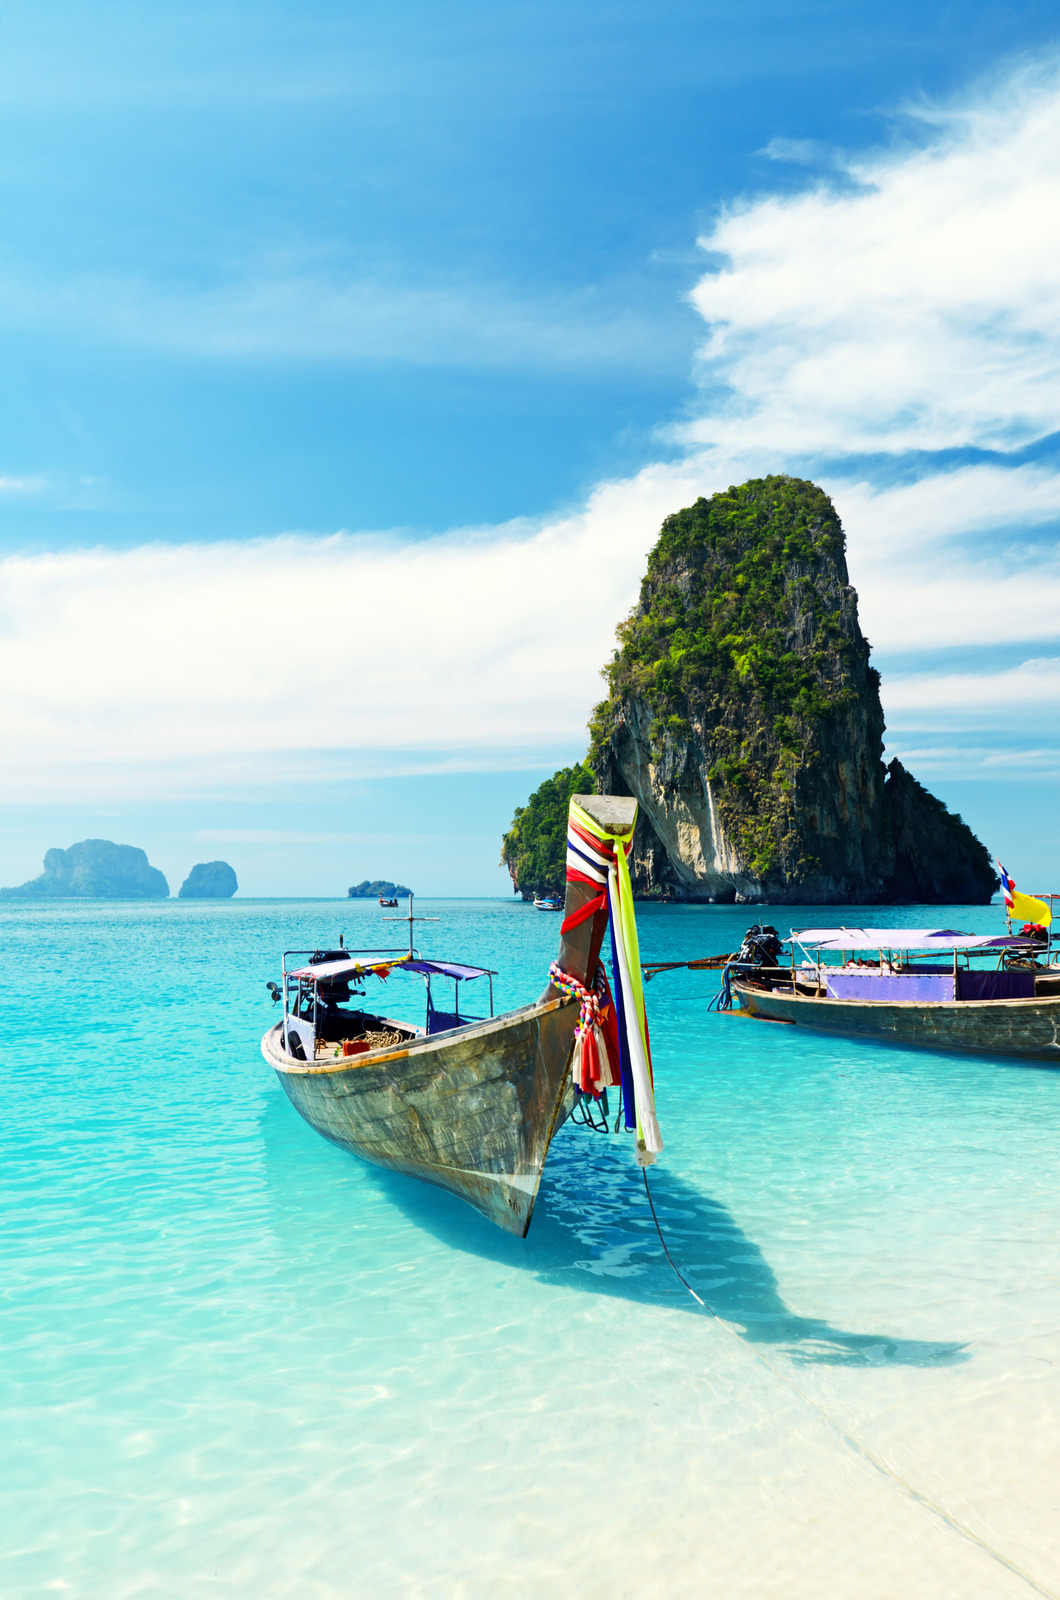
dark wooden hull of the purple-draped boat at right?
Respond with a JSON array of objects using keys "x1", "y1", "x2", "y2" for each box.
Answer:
[{"x1": 732, "y1": 982, "x2": 1060, "y2": 1066}]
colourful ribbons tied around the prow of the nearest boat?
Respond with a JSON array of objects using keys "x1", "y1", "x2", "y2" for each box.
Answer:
[{"x1": 562, "y1": 800, "x2": 663, "y2": 1166}]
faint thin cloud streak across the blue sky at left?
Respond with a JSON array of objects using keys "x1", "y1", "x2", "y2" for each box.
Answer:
[{"x1": 0, "y1": 272, "x2": 687, "y2": 374}]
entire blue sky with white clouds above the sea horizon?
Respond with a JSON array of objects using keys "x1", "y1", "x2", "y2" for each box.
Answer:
[{"x1": 0, "y1": 0, "x2": 1060, "y2": 893}]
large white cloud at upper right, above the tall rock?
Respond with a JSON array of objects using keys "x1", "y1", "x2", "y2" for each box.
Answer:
[{"x1": 690, "y1": 62, "x2": 1060, "y2": 454}]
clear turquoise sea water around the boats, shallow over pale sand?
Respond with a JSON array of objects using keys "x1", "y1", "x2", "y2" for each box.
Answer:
[{"x1": 0, "y1": 901, "x2": 1060, "y2": 1600}]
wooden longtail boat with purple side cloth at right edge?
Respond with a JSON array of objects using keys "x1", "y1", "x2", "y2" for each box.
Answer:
[{"x1": 729, "y1": 928, "x2": 1060, "y2": 1066}]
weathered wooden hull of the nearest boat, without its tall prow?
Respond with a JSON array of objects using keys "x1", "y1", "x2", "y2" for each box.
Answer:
[{"x1": 261, "y1": 997, "x2": 578, "y2": 1237}]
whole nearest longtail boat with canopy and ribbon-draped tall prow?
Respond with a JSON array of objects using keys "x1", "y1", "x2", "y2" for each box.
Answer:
[{"x1": 261, "y1": 795, "x2": 663, "y2": 1235}]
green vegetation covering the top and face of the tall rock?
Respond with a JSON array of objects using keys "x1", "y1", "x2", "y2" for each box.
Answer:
[{"x1": 588, "y1": 477, "x2": 882, "y2": 878}]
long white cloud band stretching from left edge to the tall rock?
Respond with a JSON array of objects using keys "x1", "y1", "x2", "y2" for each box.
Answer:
[{"x1": 0, "y1": 469, "x2": 714, "y2": 798}]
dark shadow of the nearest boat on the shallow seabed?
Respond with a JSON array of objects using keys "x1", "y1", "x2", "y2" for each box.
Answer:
[{"x1": 376, "y1": 1130, "x2": 969, "y2": 1366}]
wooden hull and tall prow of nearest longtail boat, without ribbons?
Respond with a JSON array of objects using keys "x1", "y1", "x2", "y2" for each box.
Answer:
[{"x1": 261, "y1": 795, "x2": 637, "y2": 1235}]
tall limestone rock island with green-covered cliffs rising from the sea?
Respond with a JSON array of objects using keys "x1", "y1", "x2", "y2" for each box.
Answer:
[{"x1": 589, "y1": 477, "x2": 996, "y2": 904}]
